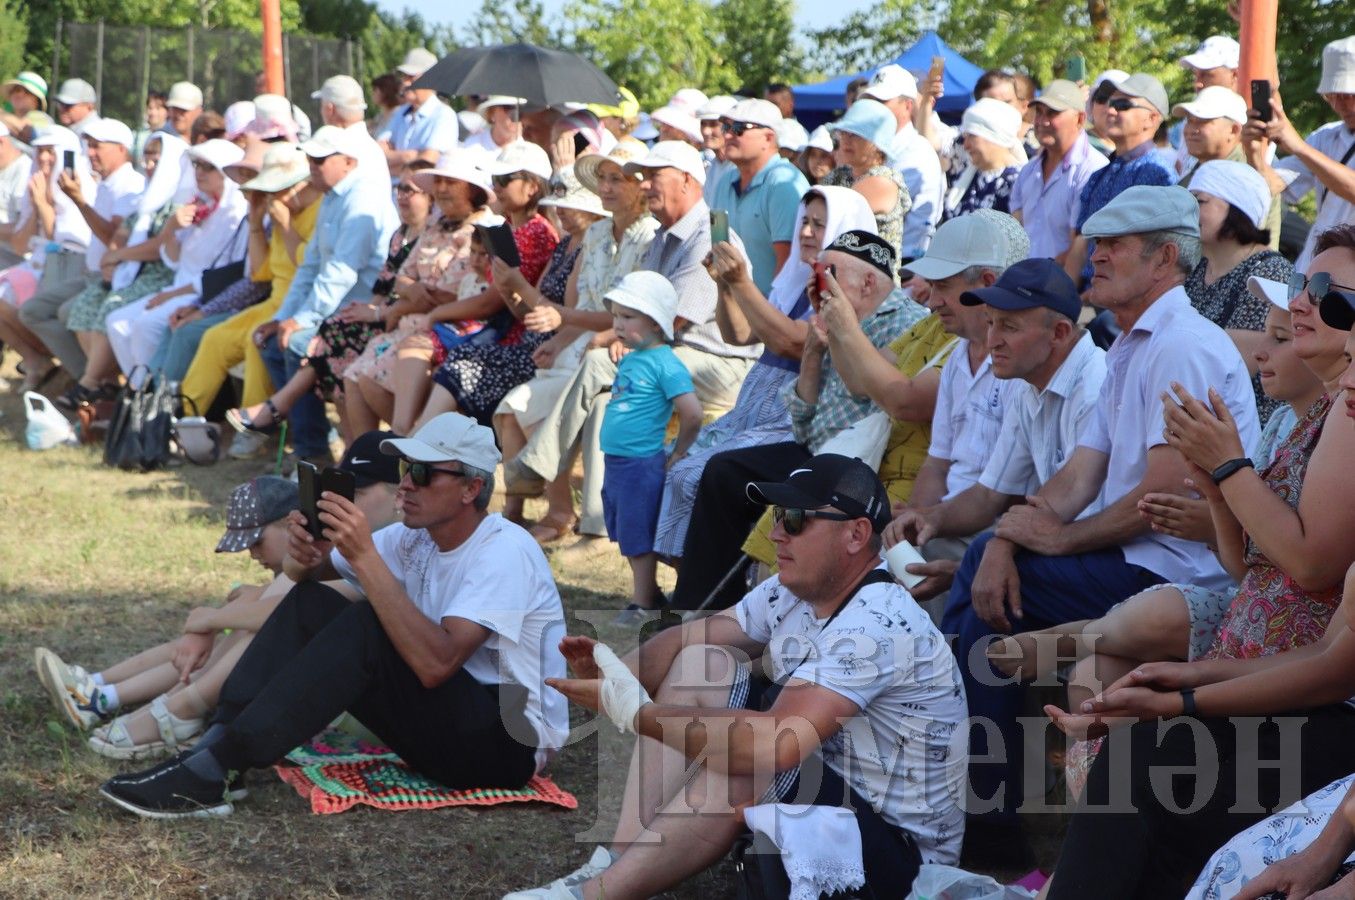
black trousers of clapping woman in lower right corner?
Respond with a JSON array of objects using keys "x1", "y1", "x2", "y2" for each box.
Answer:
[{"x1": 1049, "y1": 705, "x2": 1355, "y2": 900}]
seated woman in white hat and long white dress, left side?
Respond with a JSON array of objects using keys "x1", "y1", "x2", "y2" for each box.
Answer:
[{"x1": 106, "y1": 140, "x2": 249, "y2": 384}]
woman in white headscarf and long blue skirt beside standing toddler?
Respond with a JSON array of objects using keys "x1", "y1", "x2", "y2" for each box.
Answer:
[{"x1": 654, "y1": 186, "x2": 877, "y2": 557}]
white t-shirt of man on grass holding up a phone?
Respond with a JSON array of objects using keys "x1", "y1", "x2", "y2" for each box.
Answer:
[{"x1": 331, "y1": 514, "x2": 569, "y2": 771}]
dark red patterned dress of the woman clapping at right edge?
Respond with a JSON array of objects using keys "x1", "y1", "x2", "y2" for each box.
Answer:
[{"x1": 1205, "y1": 394, "x2": 1341, "y2": 659}]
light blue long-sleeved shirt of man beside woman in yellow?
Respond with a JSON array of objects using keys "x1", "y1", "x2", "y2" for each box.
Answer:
[{"x1": 274, "y1": 168, "x2": 400, "y2": 329}]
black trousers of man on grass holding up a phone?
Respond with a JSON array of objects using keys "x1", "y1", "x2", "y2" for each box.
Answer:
[{"x1": 211, "y1": 581, "x2": 537, "y2": 790}]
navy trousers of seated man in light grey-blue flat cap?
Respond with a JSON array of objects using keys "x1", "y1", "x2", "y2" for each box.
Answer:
[{"x1": 940, "y1": 531, "x2": 1163, "y2": 821}]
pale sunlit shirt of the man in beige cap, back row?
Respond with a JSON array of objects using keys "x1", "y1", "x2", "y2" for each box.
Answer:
[{"x1": 1011, "y1": 133, "x2": 1108, "y2": 259}]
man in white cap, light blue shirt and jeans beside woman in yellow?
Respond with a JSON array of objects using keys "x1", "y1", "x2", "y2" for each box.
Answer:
[{"x1": 255, "y1": 125, "x2": 398, "y2": 462}]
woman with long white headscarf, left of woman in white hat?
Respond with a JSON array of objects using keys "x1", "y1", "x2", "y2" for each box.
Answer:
[{"x1": 58, "y1": 131, "x2": 196, "y2": 408}]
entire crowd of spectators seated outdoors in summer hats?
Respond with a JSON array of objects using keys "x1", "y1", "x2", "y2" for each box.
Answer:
[{"x1": 0, "y1": 28, "x2": 1355, "y2": 900}]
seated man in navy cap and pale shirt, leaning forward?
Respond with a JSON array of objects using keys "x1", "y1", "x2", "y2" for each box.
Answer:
[{"x1": 885, "y1": 259, "x2": 1106, "y2": 612}]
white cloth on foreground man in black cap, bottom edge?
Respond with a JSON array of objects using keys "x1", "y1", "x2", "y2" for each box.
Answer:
[{"x1": 744, "y1": 804, "x2": 866, "y2": 900}]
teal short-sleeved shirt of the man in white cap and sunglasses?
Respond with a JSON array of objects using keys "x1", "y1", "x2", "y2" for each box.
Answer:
[{"x1": 706, "y1": 156, "x2": 809, "y2": 295}]
